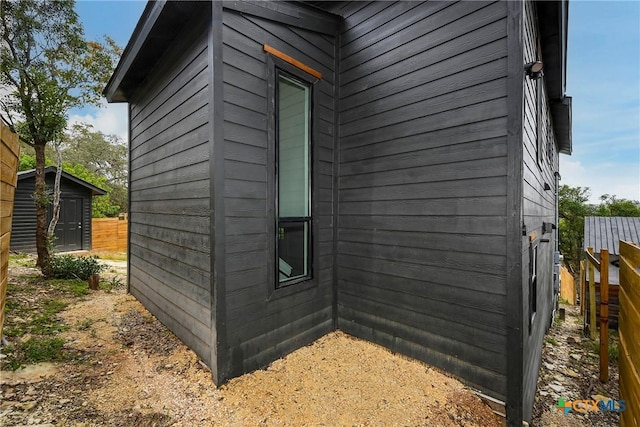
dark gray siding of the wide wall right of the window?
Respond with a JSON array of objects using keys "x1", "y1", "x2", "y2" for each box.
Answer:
[{"x1": 335, "y1": 2, "x2": 507, "y2": 400}]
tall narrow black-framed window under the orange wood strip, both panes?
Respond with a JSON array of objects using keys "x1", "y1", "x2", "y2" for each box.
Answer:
[{"x1": 276, "y1": 72, "x2": 312, "y2": 286}]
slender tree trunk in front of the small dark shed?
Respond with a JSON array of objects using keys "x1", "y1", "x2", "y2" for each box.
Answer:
[{"x1": 33, "y1": 143, "x2": 51, "y2": 277}]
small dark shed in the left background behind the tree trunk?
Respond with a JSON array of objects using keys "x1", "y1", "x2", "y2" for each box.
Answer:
[{"x1": 10, "y1": 166, "x2": 107, "y2": 252}]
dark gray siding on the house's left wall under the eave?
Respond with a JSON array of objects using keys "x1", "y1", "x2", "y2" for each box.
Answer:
[{"x1": 129, "y1": 16, "x2": 212, "y2": 366}]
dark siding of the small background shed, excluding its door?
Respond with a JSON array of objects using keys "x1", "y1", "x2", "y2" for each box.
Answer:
[{"x1": 10, "y1": 173, "x2": 92, "y2": 252}]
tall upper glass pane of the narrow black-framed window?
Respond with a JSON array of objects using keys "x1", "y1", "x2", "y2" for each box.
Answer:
[{"x1": 278, "y1": 75, "x2": 310, "y2": 218}]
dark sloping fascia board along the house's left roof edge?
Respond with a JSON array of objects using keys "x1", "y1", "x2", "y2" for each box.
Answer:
[{"x1": 102, "y1": 0, "x2": 167, "y2": 102}]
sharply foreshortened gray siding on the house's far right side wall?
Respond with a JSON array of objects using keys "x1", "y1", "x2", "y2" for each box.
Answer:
[{"x1": 522, "y1": 1, "x2": 558, "y2": 420}]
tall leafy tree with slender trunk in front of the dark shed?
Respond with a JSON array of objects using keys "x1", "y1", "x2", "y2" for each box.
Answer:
[{"x1": 0, "y1": 0, "x2": 119, "y2": 276}]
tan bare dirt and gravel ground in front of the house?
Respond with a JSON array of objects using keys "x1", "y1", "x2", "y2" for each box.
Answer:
[{"x1": 0, "y1": 263, "x2": 502, "y2": 427}]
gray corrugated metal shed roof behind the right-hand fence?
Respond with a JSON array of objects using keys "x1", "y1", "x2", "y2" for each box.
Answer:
[{"x1": 584, "y1": 216, "x2": 640, "y2": 255}]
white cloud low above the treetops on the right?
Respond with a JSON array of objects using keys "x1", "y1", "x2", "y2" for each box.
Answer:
[{"x1": 560, "y1": 156, "x2": 640, "y2": 203}]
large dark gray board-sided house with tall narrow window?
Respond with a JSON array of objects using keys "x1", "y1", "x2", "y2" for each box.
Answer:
[{"x1": 105, "y1": 1, "x2": 571, "y2": 425}]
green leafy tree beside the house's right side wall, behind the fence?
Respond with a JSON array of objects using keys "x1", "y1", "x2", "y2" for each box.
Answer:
[{"x1": 558, "y1": 185, "x2": 594, "y2": 272}]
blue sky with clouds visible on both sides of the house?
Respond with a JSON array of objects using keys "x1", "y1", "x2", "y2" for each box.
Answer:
[{"x1": 70, "y1": 0, "x2": 640, "y2": 203}]
